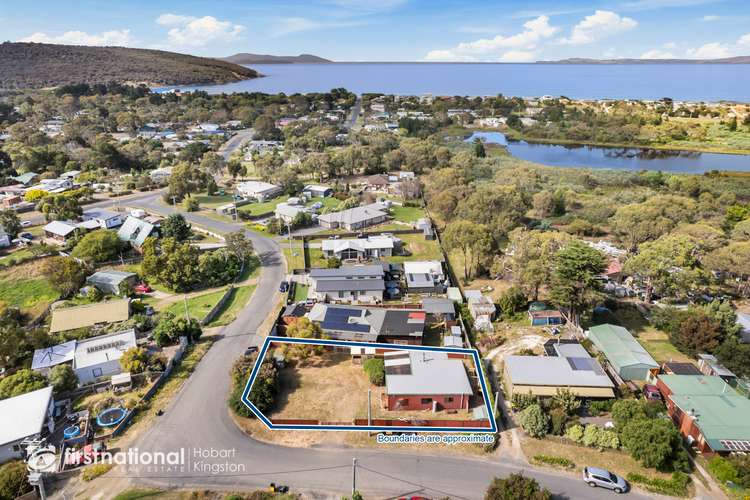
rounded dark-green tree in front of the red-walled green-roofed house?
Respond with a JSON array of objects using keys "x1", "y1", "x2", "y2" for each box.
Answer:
[{"x1": 621, "y1": 418, "x2": 688, "y2": 471}]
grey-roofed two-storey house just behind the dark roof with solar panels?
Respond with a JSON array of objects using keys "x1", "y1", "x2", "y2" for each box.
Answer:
[{"x1": 308, "y1": 265, "x2": 385, "y2": 303}]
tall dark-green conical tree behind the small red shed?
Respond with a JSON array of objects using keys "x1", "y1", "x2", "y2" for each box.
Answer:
[{"x1": 550, "y1": 240, "x2": 606, "y2": 325}]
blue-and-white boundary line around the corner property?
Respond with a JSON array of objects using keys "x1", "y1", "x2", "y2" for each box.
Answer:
[{"x1": 242, "y1": 336, "x2": 497, "y2": 434}]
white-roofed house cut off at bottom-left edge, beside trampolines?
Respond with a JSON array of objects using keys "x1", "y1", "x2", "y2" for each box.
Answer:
[{"x1": 0, "y1": 386, "x2": 55, "y2": 464}]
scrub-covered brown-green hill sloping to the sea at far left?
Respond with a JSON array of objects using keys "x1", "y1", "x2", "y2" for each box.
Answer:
[{"x1": 0, "y1": 42, "x2": 260, "y2": 89}]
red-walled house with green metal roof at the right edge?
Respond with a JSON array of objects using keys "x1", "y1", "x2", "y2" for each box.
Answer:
[{"x1": 656, "y1": 375, "x2": 750, "y2": 453}]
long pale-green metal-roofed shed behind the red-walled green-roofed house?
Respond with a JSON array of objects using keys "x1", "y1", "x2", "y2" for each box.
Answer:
[{"x1": 587, "y1": 324, "x2": 659, "y2": 380}]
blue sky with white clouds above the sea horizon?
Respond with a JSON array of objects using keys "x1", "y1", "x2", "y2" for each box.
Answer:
[{"x1": 0, "y1": 0, "x2": 750, "y2": 62}]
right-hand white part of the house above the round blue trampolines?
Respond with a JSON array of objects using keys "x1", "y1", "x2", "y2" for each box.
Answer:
[{"x1": 73, "y1": 329, "x2": 136, "y2": 384}]
